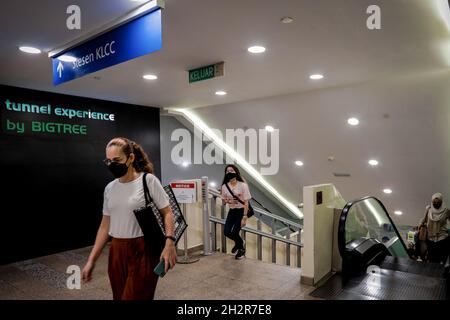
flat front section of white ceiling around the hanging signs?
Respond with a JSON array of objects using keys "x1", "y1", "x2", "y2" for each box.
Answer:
[{"x1": 0, "y1": 0, "x2": 450, "y2": 107}]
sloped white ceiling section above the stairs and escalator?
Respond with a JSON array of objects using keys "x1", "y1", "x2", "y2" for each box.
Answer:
[{"x1": 192, "y1": 70, "x2": 450, "y2": 224}]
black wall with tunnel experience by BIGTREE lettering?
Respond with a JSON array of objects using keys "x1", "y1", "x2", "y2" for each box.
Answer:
[{"x1": 0, "y1": 85, "x2": 161, "y2": 264}]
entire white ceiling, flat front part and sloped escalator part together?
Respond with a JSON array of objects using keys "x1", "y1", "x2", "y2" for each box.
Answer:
[{"x1": 0, "y1": 0, "x2": 450, "y2": 223}]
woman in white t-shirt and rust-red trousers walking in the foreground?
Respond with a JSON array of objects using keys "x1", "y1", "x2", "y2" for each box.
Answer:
[{"x1": 82, "y1": 138, "x2": 177, "y2": 300}]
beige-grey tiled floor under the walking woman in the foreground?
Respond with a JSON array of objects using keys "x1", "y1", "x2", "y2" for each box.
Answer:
[{"x1": 0, "y1": 248, "x2": 313, "y2": 300}]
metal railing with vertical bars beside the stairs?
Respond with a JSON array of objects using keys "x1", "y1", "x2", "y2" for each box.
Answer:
[{"x1": 208, "y1": 189, "x2": 303, "y2": 267}]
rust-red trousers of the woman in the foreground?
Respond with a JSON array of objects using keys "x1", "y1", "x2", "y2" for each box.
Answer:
[{"x1": 108, "y1": 237, "x2": 159, "y2": 300}]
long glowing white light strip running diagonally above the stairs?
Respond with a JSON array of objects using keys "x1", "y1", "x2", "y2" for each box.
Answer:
[{"x1": 168, "y1": 108, "x2": 303, "y2": 218}]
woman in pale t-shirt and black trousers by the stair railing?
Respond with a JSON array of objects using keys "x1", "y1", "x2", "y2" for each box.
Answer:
[{"x1": 221, "y1": 164, "x2": 252, "y2": 260}]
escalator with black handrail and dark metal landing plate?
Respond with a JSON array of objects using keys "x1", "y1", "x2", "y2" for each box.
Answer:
[{"x1": 311, "y1": 197, "x2": 449, "y2": 300}]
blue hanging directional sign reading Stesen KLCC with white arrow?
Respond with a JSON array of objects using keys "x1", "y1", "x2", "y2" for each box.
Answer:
[{"x1": 52, "y1": 9, "x2": 162, "y2": 86}]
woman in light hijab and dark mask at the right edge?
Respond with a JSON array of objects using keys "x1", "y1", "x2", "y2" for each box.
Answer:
[{"x1": 420, "y1": 193, "x2": 450, "y2": 264}]
